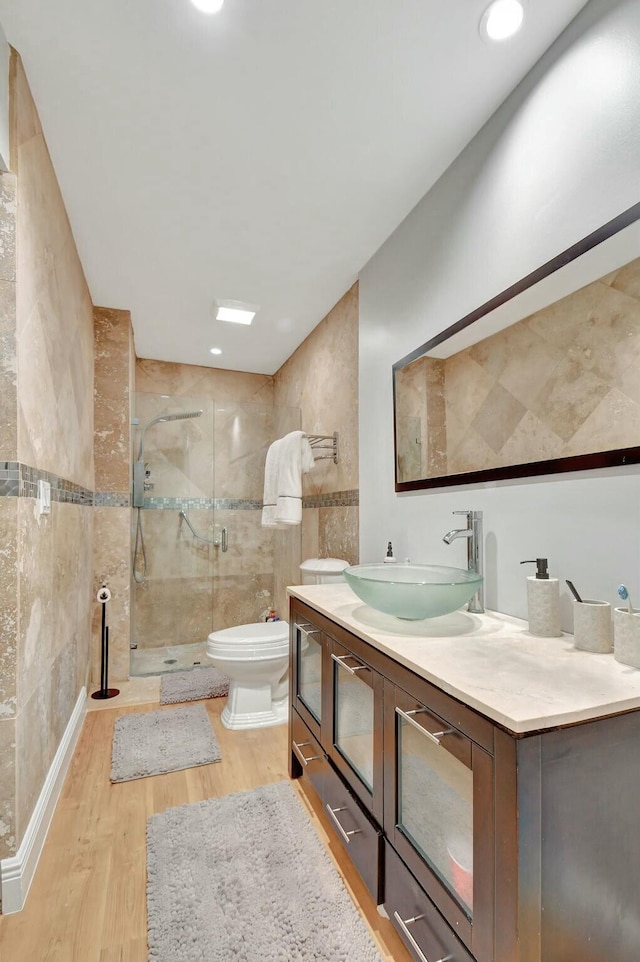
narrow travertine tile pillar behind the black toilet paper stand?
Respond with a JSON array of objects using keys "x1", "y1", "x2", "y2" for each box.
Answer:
[{"x1": 91, "y1": 307, "x2": 135, "y2": 688}]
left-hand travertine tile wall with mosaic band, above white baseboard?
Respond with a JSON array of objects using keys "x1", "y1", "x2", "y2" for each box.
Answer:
[{"x1": 0, "y1": 53, "x2": 94, "y2": 857}]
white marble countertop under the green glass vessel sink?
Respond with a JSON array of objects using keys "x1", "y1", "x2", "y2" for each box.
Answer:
[{"x1": 287, "y1": 584, "x2": 640, "y2": 734}]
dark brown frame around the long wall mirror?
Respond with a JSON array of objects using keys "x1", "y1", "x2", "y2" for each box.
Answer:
[{"x1": 392, "y1": 203, "x2": 640, "y2": 491}]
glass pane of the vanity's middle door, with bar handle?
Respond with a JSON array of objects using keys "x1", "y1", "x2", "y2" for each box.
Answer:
[{"x1": 331, "y1": 644, "x2": 374, "y2": 792}]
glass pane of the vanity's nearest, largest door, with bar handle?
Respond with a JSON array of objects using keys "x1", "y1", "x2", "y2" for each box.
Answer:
[{"x1": 395, "y1": 701, "x2": 473, "y2": 919}]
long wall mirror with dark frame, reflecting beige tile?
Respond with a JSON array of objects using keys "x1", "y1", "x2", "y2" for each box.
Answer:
[{"x1": 393, "y1": 203, "x2": 640, "y2": 491}]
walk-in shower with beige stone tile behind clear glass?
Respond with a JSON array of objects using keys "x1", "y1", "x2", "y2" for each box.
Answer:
[{"x1": 131, "y1": 392, "x2": 300, "y2": 675}]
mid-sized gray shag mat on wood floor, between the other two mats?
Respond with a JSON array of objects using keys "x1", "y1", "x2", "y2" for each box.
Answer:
[{"x1": 111, "y1": 705, "x2": 221, "y2": 782}]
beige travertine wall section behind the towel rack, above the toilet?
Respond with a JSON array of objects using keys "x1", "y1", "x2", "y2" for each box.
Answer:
[{"x1": 274, "y1": 284, "x2": 360, "y2": 610}]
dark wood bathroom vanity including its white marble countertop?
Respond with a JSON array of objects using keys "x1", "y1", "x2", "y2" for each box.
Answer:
[{"x1": 289, "y1": 585, "x2": 640, "y2": 962}]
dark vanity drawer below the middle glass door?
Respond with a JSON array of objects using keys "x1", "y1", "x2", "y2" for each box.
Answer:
[{"x1": 323, "y1": 765, "x2": 382, "y2": 902}]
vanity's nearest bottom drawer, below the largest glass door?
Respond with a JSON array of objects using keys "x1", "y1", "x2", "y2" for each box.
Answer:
[{"x1": 384, "y1": 842, "x2": 474, "y2": 962}]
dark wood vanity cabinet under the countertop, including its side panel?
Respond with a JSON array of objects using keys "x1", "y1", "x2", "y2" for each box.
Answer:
[{"x1": 289, "y1": 598, "x2": 640, "y2": 962}]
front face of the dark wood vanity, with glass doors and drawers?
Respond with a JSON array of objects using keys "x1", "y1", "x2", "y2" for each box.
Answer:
[{"x1": 290, "y1": 599, "x2": 495, "y2": 962}]
